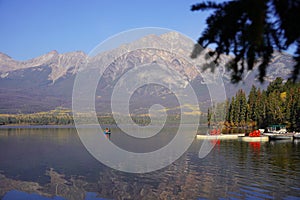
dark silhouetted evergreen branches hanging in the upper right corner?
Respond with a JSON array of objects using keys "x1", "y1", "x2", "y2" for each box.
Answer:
[{"x1": 191, "y1": 0, "x2": 300, "y2": 83}]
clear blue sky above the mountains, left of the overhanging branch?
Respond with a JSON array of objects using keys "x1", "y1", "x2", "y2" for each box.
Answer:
[{"x1": 0, "y1": 0, "x2": 214, "y2": 60}]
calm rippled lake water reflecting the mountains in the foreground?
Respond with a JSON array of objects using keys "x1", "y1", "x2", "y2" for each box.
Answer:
[{"x1": 0, "y1": 128, "x2": 300, "y2": 199}]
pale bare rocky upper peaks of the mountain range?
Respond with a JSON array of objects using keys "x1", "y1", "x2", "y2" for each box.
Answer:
[{"x1": 0, "y1": 32, "x2": 294, "y2": 85}]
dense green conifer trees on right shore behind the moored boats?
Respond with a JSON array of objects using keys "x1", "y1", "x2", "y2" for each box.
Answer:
[{"x1": 208, "y1": 78, "x2": 300, "y2": 131}]
